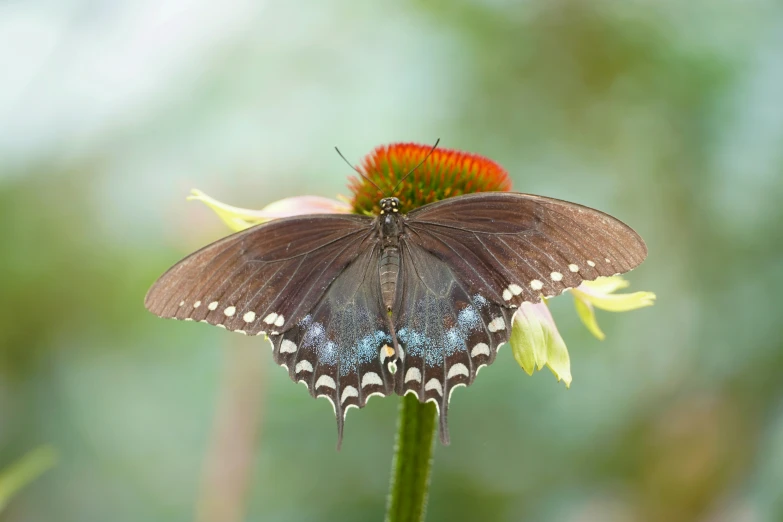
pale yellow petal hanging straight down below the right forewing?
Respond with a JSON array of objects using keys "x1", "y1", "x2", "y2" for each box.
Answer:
[{"x1": 509, "y1": 301, "x2": 572, "y2": 387}]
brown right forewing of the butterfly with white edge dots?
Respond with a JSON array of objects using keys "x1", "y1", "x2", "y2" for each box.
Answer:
[{"x1": 406, "y1": 192, "x2": 647, "y2": 307}]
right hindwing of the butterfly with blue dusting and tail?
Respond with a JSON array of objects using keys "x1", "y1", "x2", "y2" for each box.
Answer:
[{"x1": 395, "y1": 241, "x2": 513, "y2": 444}]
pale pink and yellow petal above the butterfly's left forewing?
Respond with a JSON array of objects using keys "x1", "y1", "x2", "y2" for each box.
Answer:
[{"x1": 188, "y1": 189, "x2": 351, "y2": 232}]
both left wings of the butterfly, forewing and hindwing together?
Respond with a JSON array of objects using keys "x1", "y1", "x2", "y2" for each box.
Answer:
[{"x1": 145, "y1": 215, "x2": 394, "y2": 446}]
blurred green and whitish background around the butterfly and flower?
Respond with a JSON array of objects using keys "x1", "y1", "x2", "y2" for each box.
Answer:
[{"x1": 0, "y1": 0, "x2": 783, "y2": 522}]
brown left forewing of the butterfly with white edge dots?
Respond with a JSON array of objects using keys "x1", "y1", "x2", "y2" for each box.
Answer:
[{"x1": 144, "y1": 214, "x2": 373, "y2": 335}]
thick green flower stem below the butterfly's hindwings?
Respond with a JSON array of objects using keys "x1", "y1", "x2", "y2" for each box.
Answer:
[{"x1": 386, "y1": 394, "x2": 437, "y2": 522}]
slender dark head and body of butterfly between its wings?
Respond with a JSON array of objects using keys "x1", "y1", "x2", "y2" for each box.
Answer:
[{"x1": 378, "y1": 198, "x2": 403, "y2": 312}]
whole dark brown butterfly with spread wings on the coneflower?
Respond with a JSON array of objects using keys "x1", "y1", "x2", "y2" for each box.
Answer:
[{"x1": 145, "y1": 183, "x2": 647, "y2": 447}]
